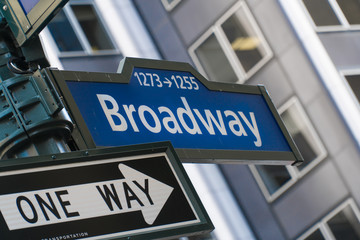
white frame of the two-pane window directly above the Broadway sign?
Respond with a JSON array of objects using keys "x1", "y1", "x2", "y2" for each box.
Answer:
[{"x1": 188, "y1": 1, "x2": 273, "y2": 84}]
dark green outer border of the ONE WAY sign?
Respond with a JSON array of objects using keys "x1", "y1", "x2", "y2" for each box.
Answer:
[{"x1": 0, "y1": 142, "x2": 214, "y2": 240}]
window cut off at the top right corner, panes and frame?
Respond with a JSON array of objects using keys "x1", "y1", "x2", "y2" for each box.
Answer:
[{"x1": 302, "y1": 0, "x2": 360, "y2": 31}]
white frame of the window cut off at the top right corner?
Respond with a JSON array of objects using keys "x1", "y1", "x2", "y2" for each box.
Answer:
[{"x1": 298, "y1": 0, "x2": 360, "y2": 32}]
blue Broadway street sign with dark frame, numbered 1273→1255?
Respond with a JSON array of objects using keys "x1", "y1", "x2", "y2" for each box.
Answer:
[{"x1": 46, "y1": 58, "x2": 302, "y2": 164}]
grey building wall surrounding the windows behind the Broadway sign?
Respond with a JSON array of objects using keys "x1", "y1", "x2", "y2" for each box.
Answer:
[{"x1": 134, "y1": 0, "x2": 360, "y2": 239}]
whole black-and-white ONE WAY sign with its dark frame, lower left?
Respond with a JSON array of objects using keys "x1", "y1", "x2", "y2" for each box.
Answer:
[{"x1": 0, "y1": 142, "x2": 213, "y2": 240}]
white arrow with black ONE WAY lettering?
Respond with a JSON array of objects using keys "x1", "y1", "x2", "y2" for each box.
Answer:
[{"x1": 0, "y1": 163, "x2": 174, "y2": 230}]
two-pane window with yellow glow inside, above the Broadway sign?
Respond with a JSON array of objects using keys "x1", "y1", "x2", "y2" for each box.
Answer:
[{"x1": 189, "y1": 2, "x2": 272, "y2": 83}]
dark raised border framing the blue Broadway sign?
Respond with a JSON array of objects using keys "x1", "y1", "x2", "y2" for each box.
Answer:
[{"x1": 44, "y1": 57, "x2": 303, "y2": 165}]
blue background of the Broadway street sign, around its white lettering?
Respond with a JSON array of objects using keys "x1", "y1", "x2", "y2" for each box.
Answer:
[{"x1": 67, "y1": 68, "x2": 291, "y2": 152}]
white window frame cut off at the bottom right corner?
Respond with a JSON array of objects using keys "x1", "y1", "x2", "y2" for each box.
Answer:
[{"x1": 297, "y1": 198, "x2": 360, "y2": 240}]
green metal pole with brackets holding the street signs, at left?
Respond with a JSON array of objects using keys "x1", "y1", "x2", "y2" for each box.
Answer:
[{"x1": 0, "y1": 18, "x2": 73, "y2": 159}]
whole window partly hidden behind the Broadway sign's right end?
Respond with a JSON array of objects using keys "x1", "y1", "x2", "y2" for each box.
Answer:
[{"x1": 250, "y1": 98, "x2": 326, "y2": 201}]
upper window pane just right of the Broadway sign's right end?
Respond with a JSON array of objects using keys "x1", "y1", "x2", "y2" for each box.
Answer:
[{"x1": 281, "y1": 103, "x2": 321, "y2": 170}]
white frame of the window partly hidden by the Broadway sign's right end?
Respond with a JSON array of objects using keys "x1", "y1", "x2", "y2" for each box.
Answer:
[{"x1": 249, "y1": 96, "x2": 327, "y2": 203}]
